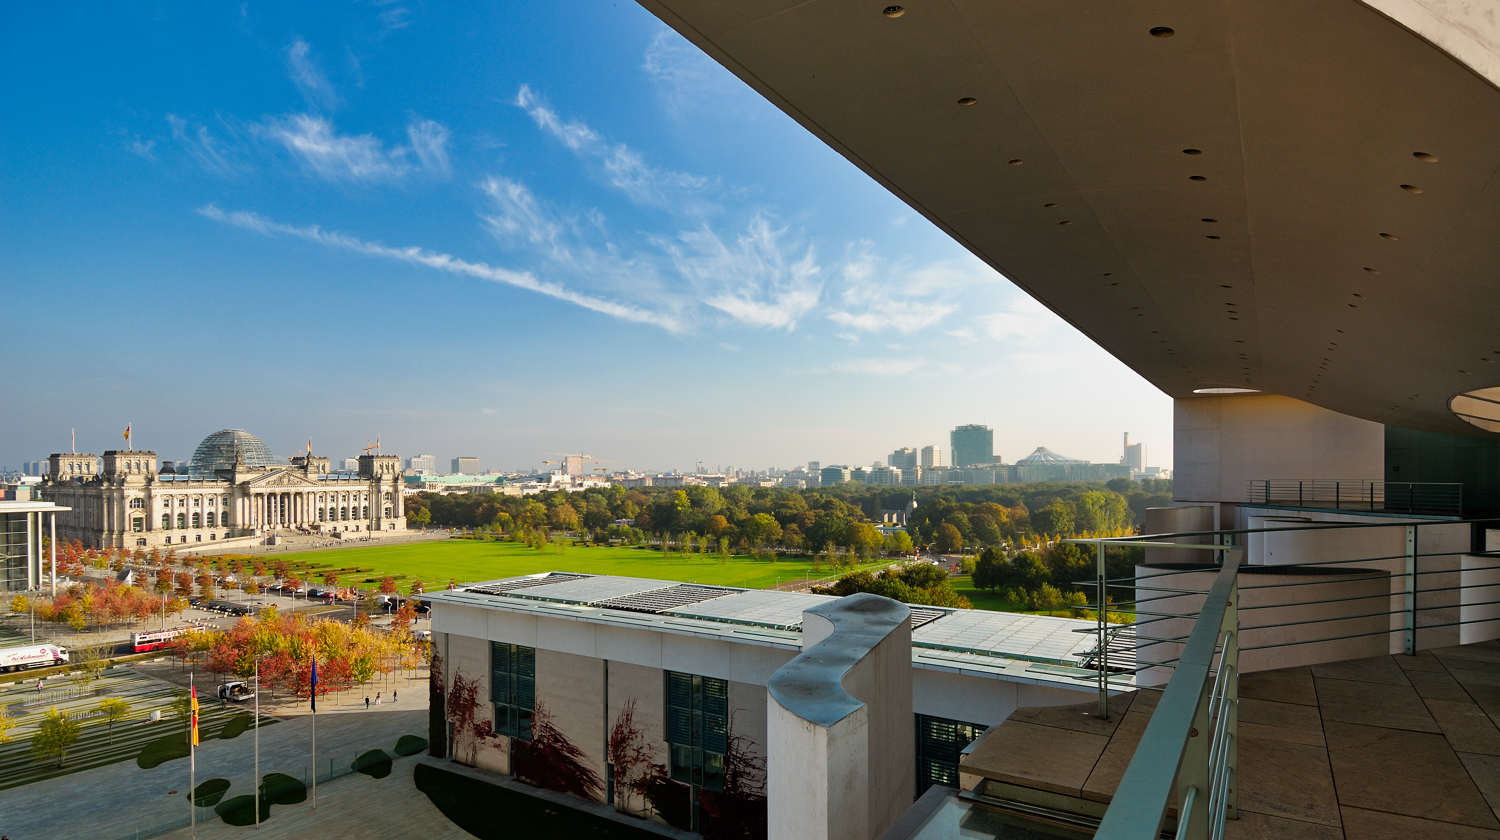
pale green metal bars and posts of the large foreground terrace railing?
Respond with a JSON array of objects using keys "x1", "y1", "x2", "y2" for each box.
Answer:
[{"x1": 1067, "y1": 518, "x2": 1500, "y2": 840}]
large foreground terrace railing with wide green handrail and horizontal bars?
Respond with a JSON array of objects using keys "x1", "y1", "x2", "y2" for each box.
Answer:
[{"x1": 1068, "y1": 521, "x2": 1500, "y2": 840}]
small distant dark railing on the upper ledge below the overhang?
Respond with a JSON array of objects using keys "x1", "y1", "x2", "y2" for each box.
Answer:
[{"x1": 1245, "y1": 479, "x2": 1464, "y2": 516}]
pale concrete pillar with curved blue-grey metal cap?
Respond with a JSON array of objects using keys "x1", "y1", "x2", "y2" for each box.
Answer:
[{"x1": 767, "y1": 594, "x2": 917, "y2": 840}]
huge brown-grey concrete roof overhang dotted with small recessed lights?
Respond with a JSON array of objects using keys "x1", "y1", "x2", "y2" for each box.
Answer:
[{"x1": 641, "y1": 0, "x2": 1500, "y2": 434}]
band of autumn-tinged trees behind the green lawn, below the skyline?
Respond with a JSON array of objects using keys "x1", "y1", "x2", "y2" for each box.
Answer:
[{"x1": 407, "y1": 479, "x2": 1172, "y2": 558}]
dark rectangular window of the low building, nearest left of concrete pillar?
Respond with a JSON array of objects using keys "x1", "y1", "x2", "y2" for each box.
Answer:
[{"x1": 666, "y1": 671, "x2": 729, "y2": 791}]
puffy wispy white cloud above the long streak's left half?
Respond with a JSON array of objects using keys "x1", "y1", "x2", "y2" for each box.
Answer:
[{"x1": 257, "y1": 114, "x2": 449, "y2": 182}]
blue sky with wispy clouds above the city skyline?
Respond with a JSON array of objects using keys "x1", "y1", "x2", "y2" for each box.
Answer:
[{"x1": 0, "y1": 0, "x2": 1172, "y2": 468}]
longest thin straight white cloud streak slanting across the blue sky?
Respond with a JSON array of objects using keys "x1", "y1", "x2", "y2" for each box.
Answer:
[{"x1": 198, "y1": 204, "x2": 683, "y2": 333}]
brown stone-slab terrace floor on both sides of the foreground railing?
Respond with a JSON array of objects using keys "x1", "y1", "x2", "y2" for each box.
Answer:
[{"x1": 965, "y1": 642, "x2": 1500, "y2": 840}]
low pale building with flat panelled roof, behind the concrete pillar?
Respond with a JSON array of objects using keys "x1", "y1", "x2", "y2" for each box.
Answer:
[{"x1": 428, "y1": 572, "x2": 1092, "y2": 836}]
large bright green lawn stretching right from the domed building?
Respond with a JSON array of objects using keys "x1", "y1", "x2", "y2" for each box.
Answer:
[{"x1": 261, "y1": 540, "x2": 879, "y2": 593}]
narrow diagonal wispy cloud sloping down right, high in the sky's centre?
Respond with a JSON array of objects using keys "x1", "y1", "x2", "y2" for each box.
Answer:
[{"x1": 516, "y1": 84, "x2": 714, "y2": 212}]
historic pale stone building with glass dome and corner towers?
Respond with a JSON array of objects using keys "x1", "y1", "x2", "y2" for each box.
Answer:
[{"x1": 41, "y1": 429, "x2": 407, "y2": 549}]
